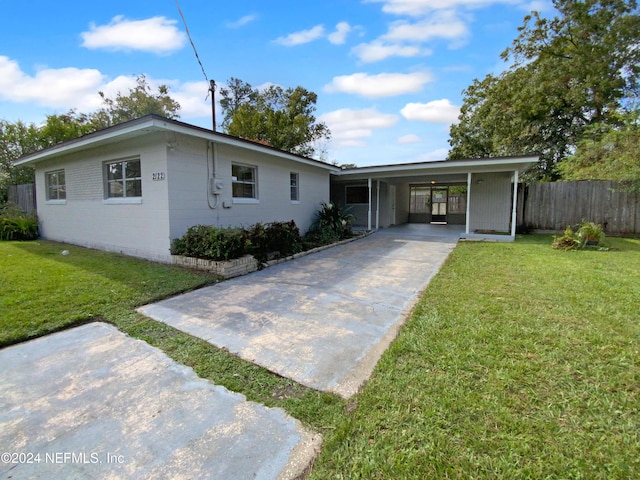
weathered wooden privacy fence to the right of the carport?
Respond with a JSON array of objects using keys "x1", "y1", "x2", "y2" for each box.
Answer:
[{"x1": 518, "y1": 180, "x2": 640, "y2": 235}]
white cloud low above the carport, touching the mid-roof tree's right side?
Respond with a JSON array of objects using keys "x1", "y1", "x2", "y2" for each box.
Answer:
[{"x1": 318, "y1": 108, "x2": 398, "y2": 147}]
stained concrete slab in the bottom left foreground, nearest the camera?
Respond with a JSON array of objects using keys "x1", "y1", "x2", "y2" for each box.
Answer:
[{"x1": 0, "y1": 323, "x2": 320, "y2": 480}]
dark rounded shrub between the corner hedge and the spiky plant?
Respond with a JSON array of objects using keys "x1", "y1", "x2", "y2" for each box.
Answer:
[{"x1": 247, "y1": 220, "x2": 302, "y2": 262}]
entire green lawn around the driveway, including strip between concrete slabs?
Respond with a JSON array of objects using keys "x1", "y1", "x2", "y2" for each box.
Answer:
[{"x1": 0, "y1": 236, "x2": 640, "y2": 479}]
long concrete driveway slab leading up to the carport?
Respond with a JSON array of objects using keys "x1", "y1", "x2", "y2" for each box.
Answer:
[{"x1": 139, "y1": 225, "x2": 458, "y2": 398}]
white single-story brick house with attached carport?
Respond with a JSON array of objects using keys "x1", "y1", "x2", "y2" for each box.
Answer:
[{"x1": 16, "y1": 115, "x2": 537, "y2": 262}]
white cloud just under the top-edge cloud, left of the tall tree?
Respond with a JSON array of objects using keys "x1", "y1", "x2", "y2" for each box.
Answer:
[{"x1": 382, "y1": 11, "x2": 469, "y2": 44}]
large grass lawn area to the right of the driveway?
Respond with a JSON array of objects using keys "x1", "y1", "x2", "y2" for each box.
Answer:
[{"x1": 312, "y1": 236, "x2": 640, "y2": 480}]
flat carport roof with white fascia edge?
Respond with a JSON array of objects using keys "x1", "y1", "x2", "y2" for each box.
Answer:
[{"x1": 333, "y1": 155, "x2": 538, "y2": 183}]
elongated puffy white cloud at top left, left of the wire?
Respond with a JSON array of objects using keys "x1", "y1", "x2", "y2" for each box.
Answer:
[{"x1": 81, "y1": 15, "x2": 187, "y2": 54}]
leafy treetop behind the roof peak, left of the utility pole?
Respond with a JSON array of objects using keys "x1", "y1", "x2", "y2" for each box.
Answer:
[{"x1": 90, "y1": 75, "x2": 180, "y2": 130}]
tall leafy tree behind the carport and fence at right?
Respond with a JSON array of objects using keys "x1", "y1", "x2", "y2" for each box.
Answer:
[{"x1": 449, "y1": 0, "x2": 640, "y2": 178}]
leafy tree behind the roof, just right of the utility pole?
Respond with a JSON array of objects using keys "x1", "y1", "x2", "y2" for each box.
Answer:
[{"x1": 220, "y1": 78, "x2": 331, "y2": 157}]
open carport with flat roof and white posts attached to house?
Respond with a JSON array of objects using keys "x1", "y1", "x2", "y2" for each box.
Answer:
[{"x1": 331, "y1": 155, "x2": 538, "y2": 241}]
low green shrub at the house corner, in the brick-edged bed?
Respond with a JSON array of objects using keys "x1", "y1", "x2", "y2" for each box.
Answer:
[{"x1": 171, "y1": 225, "x2": 247, "y2": 261}]
